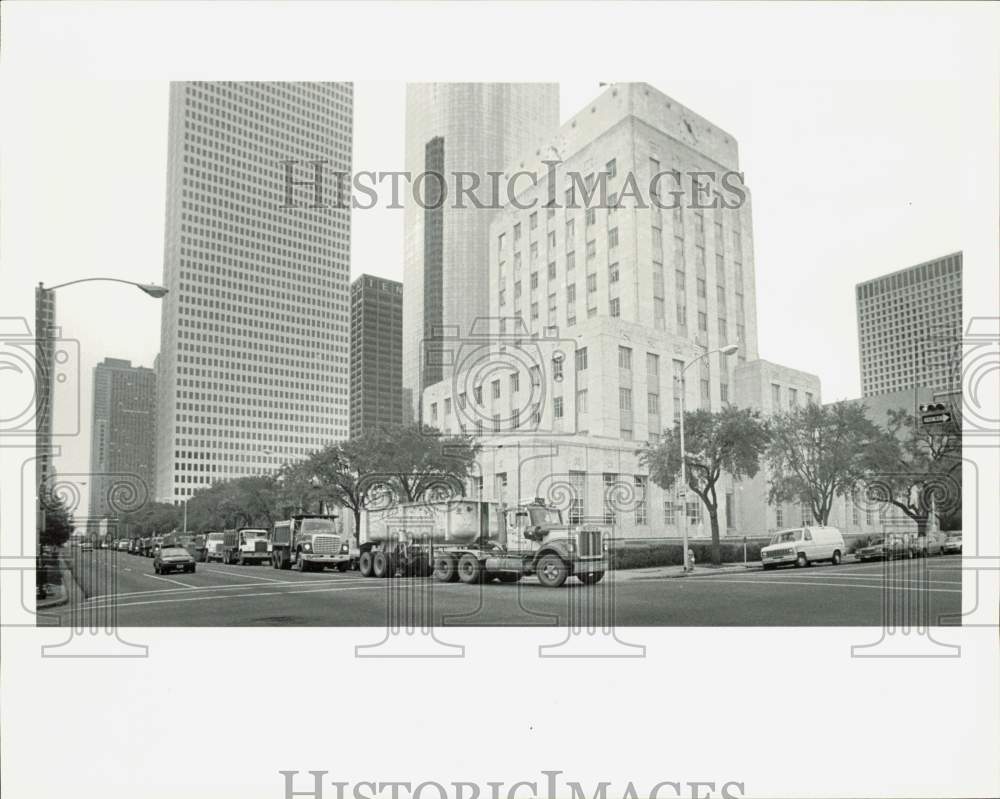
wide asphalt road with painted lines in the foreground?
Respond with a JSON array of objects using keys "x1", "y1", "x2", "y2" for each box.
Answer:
[{"x1": 45, "y1": 550, "x2": 962, "y2": 627}]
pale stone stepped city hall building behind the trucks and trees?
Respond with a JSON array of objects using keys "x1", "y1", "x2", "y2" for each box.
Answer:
[{"x1": 422, "y1": 84, "x2": 821, "y2": 538}]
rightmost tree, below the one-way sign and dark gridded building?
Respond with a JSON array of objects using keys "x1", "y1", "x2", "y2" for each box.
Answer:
[{"x1": 865, "y1": 409, "x2": 962, "y2": 535}]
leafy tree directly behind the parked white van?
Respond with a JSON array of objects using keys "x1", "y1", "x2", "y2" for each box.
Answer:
[{"x1": 767, "y1": 402, "x2": 882, "y2": 525}]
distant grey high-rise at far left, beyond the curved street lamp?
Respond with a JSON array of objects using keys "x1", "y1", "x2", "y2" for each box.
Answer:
[{"x1": 90, "y1": 358, "x2": 156, "y2": 519}]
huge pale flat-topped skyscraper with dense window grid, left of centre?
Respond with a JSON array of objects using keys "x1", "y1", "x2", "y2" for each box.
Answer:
[{"x1": 156, "y1": 83, "x2": 353, "y2": 502}]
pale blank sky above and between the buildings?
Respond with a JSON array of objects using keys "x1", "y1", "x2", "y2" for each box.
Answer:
[{"x1": 0, "y1": 4, "x2": 997, "y2": 524}]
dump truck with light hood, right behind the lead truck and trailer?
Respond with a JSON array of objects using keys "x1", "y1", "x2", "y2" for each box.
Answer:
[{"x1": 267, "y1": 514, "x2": 351, "y2": 571}]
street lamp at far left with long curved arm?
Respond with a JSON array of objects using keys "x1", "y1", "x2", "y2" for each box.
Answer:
[{"x1": 35, "y1": 277, "x2": 168, "y2": 564}]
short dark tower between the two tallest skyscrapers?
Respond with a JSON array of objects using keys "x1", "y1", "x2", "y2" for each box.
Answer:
[{"x1": 351, "y1": 275, "x2": 403, "y2": 438}]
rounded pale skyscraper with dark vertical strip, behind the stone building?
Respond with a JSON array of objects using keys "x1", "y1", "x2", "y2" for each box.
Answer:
[{"x1": 403, "y1": 83, "x2": 559, "y2": 412}]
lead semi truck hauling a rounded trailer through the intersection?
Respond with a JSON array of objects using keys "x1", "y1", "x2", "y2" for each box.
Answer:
[{"x1": 358, "y1": 498, "x2": 607, "y2": 588}]
